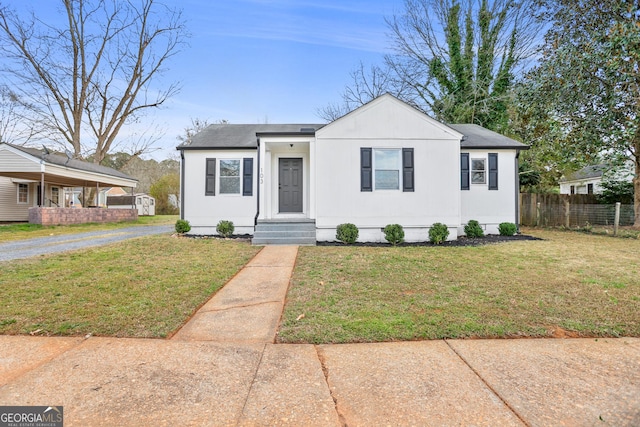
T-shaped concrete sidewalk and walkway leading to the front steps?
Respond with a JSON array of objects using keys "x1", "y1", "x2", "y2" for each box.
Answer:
[{"x1": 0, "y1": 246, "x2": 640, "y2": 426}]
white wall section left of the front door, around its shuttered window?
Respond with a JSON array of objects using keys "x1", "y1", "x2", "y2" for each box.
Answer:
[{"x1": 183, "y1": 150, "x2": 257, "y2": 235}]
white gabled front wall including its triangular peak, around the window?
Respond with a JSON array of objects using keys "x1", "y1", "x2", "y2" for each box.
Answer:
[{"x1": 313, "y1": 98, "x2": 461, "y2": 241}]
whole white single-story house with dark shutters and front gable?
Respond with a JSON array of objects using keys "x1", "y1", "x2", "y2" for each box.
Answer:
[{"x1": 177, "y1": 94, "x2": 528, "y2": 244}]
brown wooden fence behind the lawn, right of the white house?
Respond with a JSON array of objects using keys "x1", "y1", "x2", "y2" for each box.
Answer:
[{"x1": 520, "y1": 193, "x2": 634, "y2": 228}]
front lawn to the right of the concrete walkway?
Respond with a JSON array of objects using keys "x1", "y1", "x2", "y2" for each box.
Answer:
[{"x1": 278, "y1": 229, "x2": 640, "y2": 343}]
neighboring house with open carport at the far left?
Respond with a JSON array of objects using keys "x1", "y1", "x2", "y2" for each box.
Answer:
[{"x1": 0, "y1": 143, "x2": 137, "y2": 221}]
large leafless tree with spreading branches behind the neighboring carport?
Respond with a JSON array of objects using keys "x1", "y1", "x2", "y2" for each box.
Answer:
[{"x1": 0, "y1": 0, "x2": 187, "y2": 163}]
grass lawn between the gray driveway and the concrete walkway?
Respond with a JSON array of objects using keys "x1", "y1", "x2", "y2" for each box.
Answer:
[{"x1": 0, "y1": 235, "x2": 260, "y2": 337}]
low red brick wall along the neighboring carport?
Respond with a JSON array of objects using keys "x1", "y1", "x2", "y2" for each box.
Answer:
[{"x1": 29, "y1": 208, "x2": 138, "y2": 225}]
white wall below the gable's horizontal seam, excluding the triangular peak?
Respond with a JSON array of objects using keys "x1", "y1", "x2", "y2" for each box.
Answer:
[{"x1": 316, "y1": 140, "x2": 460, "y2": 241}]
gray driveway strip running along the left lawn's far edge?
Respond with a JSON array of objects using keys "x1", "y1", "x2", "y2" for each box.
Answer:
[{"x1": 0, "y1": 225, "x2": 174, "y2": 261}]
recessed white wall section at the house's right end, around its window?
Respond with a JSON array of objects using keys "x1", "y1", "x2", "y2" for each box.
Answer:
[{"x1": 458, "y1": 150, "x2": 517, "y2": 234}]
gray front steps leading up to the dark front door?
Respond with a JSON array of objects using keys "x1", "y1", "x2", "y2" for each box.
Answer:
[{"x1": 251, "y1": 219, "x2": 316, "y2": 246}]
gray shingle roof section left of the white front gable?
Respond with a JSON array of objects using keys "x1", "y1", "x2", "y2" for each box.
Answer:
[{"x1": 177, "y1": 124, "x2": 324, "y2": 150}]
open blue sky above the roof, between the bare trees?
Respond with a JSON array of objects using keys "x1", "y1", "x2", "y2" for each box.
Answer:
[{"x1": 154, "y1": 0, "x2": 403, "y2": 158}]
